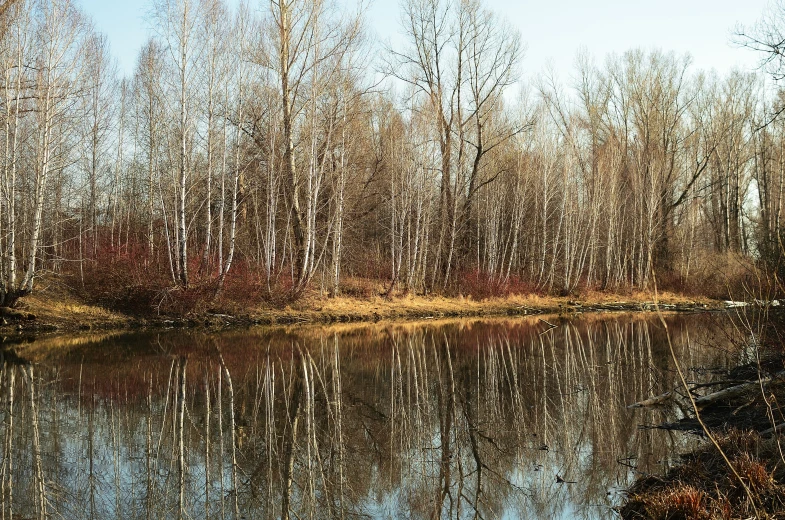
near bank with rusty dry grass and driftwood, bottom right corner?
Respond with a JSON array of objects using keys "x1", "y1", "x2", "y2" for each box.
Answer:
[{"x1": 618, "y1": 313, "x2": 785, "y2": 520}]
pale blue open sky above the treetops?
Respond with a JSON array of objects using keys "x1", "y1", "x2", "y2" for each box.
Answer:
[{"x1": 77, "y1": 0, "x2": 768, "y2": 81}]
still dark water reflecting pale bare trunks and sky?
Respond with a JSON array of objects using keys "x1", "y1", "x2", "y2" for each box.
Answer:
[{"x1": 0, "y1": 315, "x2": 734, "y2": 519}]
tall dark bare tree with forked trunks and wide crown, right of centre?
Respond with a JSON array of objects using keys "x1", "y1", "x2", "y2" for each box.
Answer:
[{"x1": 387, "y1": 0, "x2": 527, "y2": 284}]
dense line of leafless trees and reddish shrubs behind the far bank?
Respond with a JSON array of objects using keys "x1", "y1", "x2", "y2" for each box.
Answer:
[{"x1": 0, "y1": 0, "x2": 785, "y2": 305}]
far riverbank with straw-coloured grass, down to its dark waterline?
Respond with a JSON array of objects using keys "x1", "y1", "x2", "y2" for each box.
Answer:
[{"x1": 0, "y1": 284, "x2": 725, "y2": 334}]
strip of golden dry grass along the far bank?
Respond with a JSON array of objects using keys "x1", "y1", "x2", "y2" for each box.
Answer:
[{"x1": 1, "y1": 277, "x2": 709, "y2": 330}]
